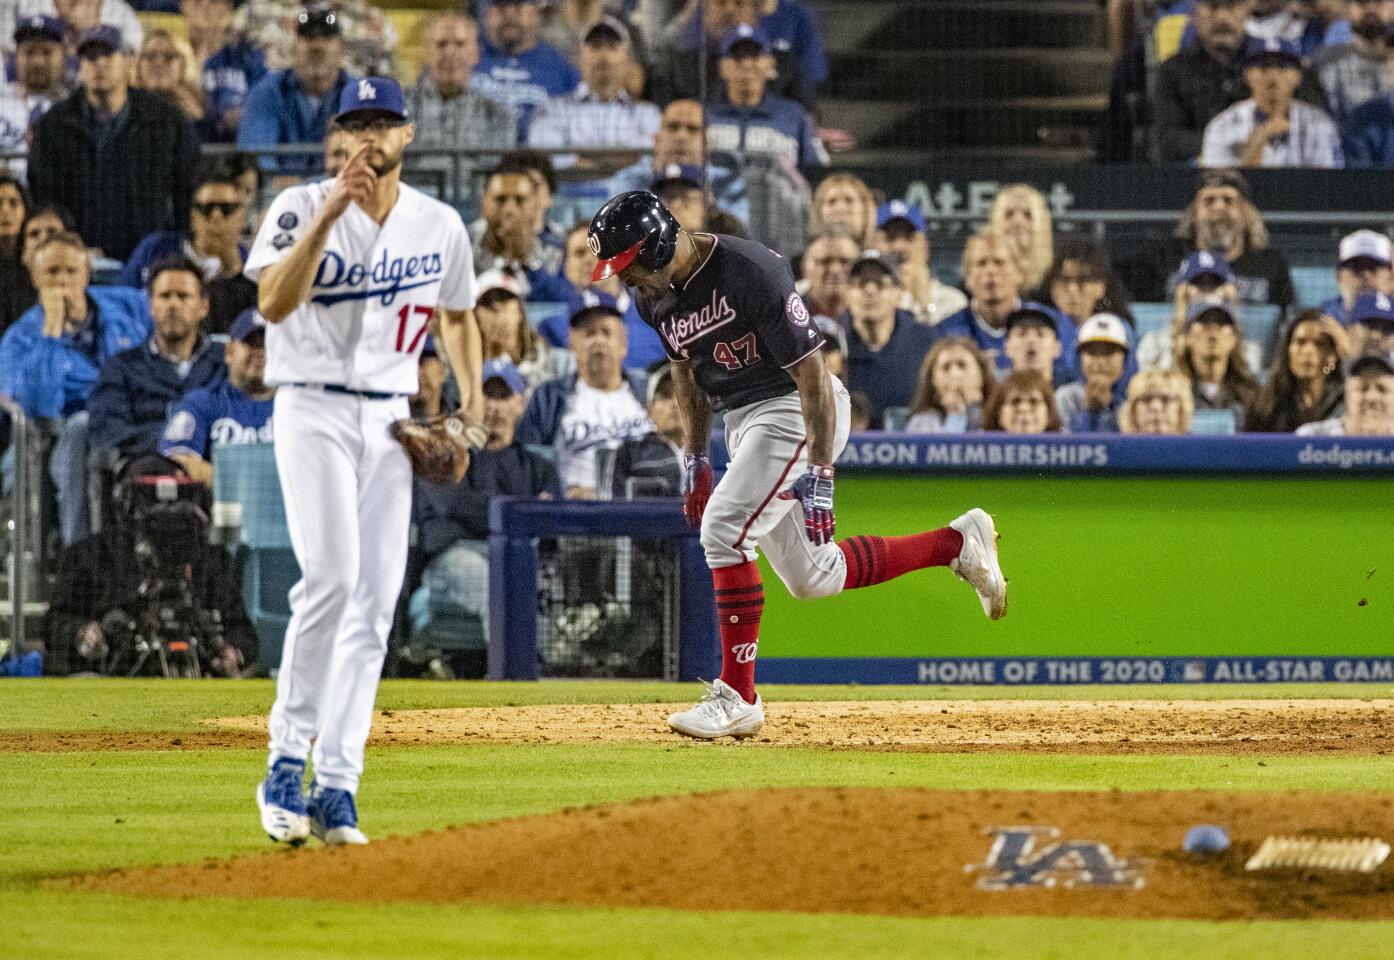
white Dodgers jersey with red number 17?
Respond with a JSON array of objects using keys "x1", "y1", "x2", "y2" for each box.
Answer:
[{"x1": 243, "y1": 180, "x2": 475, "y2": 394}]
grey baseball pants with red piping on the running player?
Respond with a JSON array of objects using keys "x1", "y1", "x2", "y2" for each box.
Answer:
[{"x1": 701, "y1": 375, "x2": 852, "y2": 590}]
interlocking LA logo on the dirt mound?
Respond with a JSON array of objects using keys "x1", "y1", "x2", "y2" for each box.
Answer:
[{"x1": 963, "y1": 826, "x2": 1144, "y2": 890}]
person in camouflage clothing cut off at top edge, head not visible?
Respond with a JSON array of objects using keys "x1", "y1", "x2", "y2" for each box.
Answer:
[{"x1": 233, "y1": 0, "x2": 397, "y2": 77}]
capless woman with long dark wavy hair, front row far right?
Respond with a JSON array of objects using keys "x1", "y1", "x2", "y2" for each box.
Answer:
[{"x1": 1243, "y1": 308, "x2": 1349, "y2": 433}]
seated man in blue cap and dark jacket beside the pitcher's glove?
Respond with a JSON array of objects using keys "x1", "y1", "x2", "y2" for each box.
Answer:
[{"x1": 406, "y1": 359, "x2": 562, "y2": 654}]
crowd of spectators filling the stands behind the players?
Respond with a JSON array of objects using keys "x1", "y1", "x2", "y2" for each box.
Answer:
[{"x1": 0, "y1": 0, "x2": 1394, "y2": 674}]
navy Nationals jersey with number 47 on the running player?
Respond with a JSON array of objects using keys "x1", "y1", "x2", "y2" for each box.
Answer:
[{"x1": 634, "y1": 234, "x2": 822, "y2": 411}]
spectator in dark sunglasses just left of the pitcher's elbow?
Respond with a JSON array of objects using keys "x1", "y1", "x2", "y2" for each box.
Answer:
[{"x1": 117, "y1": 169, "x2": 256, "y2": 333}]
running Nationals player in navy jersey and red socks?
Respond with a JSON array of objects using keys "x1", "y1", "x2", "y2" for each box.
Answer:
[{"x1": 588, "y1": 192, "x2": 1006, "y2": 740}]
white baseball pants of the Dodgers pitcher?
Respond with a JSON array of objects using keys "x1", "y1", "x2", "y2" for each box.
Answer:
[{"x1": 270, "y1": 386, "x2": 411, "y2": 791}]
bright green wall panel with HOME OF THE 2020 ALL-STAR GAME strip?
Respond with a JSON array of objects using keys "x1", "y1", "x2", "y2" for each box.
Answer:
[{"x1": 758, "y1": 472, "x2": 1394, "y2": 684}]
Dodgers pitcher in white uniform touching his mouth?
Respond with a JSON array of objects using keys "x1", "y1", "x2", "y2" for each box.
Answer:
[{"x1": 245, "y1": 77, "x2": 482, "y2": 844}]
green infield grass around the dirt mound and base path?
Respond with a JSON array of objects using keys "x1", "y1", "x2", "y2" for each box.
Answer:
[{"x1": 0, "y1": 681, "x2": 1394, "y2": 960}]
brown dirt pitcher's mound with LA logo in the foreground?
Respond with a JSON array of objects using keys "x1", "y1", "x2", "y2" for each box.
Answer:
[{"x1": 72, "y1": 787, "x2": 1394, "y2": 920}]
